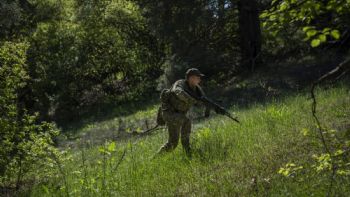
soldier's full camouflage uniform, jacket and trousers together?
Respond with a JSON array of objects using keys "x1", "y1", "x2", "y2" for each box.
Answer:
[{"x1": 159, "y1": 79, "x2": 204, "y2": 155}]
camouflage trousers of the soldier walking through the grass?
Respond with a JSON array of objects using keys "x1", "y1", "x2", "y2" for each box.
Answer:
[{"x1": 159, "y1": 111, "x2": 191, "y2": 156}]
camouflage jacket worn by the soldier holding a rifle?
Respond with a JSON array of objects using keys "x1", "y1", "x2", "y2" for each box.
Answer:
[{"x1": 168, "y1": 79, "x2": 205, "y2": 113}]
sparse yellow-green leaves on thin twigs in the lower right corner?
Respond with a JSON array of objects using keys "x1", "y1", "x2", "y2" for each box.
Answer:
[{"x1": 278, "y1": 87, "x2": 350, "y2": 195}]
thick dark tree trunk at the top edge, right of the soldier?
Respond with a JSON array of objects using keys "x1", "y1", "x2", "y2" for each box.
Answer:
[{"x1": 238, "y1": 0, "x2": 261, "y2": 72}]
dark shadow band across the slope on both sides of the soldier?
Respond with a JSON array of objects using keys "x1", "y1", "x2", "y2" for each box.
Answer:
[{"x1": 59, "y1": 53, "x2": 350, "y2": 138}]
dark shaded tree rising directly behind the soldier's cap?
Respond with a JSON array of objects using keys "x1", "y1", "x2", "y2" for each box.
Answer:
[{"x1": 135, "y1": 0, "x2": 243, "y2": 80}]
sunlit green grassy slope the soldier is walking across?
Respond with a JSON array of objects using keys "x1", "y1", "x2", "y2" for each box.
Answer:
[{"x1": 23, "y1": 84, "x2": 350, "y2": 196}]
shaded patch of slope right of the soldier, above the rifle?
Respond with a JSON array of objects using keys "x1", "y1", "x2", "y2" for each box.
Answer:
[{"x1": 208, "y1": 53, "x2": 350, "y2": 109}]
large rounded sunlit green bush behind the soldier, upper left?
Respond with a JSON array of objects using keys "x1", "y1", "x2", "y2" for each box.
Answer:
[{"x1": 29, "y1": 0, "x2": 161, "y2": 123}]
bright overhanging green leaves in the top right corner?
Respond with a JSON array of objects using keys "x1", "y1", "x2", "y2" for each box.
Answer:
[{"x1": 260, "y1": 0, "x2": 350, "y2": 47}]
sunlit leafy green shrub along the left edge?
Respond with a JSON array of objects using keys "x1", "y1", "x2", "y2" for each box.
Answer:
[{"x1": 0, "y1": 42, "x2": 59, "y2": 187}]
